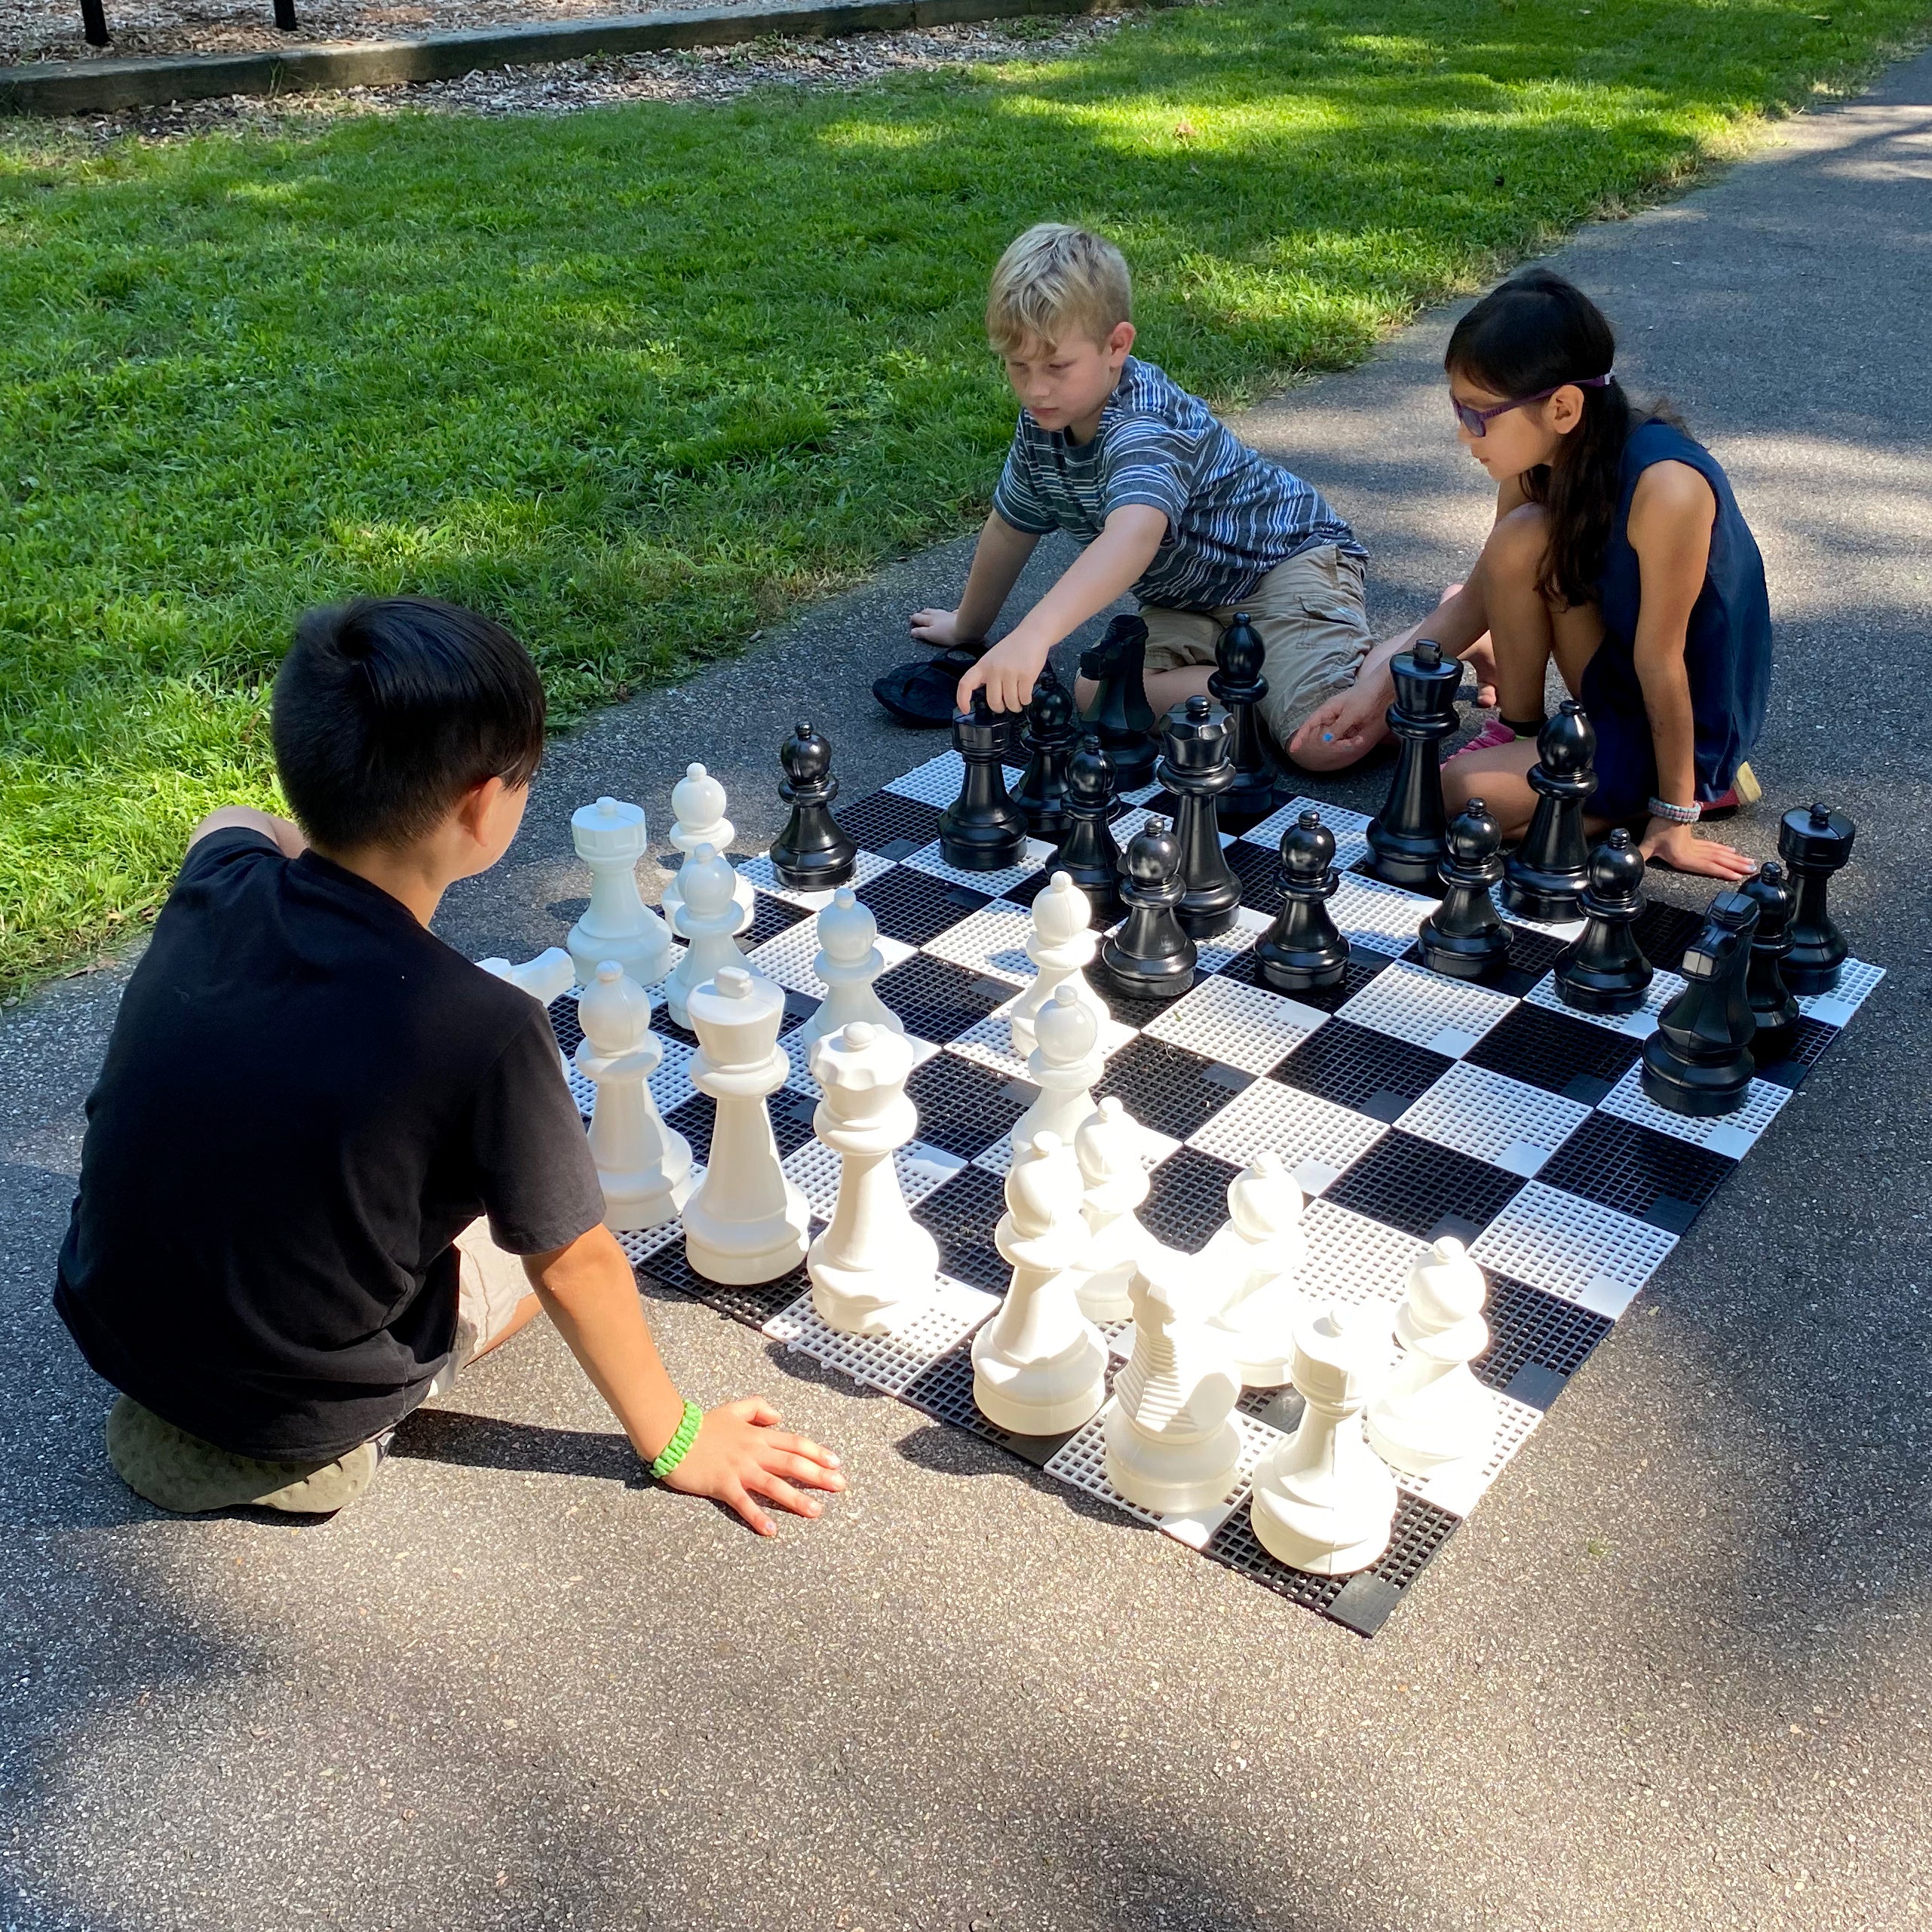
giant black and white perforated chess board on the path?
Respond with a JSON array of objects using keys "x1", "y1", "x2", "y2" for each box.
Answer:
[{"x1": 550, "y1": 752, "x2": 1881, "y2": 1636}]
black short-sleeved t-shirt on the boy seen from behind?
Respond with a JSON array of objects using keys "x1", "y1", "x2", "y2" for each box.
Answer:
[{"x1": 54, "y1": 829, "x2": 605, "y2": 1461}]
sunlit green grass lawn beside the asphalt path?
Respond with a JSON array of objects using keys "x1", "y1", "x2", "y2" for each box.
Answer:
[{"x1": 0, "y1": 0, "x2": 1926, "y2": 983}]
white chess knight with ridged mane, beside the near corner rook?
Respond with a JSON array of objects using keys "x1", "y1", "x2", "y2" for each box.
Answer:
[{"x1": 1105, "y1": 1256, "x2": 1240, "y2": 1516}]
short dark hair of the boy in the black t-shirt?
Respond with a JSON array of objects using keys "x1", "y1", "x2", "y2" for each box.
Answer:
[{"x1": 272, "y1": 597, "x2": 543, "y2": 850}]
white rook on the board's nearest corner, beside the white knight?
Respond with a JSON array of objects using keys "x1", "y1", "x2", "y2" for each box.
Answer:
[{"x1": 1250, "y1": 1308, "x2": 1397, "y2": 1577}]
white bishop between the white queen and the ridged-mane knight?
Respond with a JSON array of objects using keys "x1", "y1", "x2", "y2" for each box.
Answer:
[{"x1": 972, "y1": 1134, "x2": 1107, "y2": 1436}]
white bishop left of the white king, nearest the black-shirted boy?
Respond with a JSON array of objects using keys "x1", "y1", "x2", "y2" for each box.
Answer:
[{"x1": 578, "y1": 960, "x2": 692, "y2": 1233}]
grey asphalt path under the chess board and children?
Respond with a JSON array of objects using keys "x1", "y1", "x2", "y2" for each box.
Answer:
[{"x1": 0, "y1": 45, "x2": 1932, "y2": 1932}]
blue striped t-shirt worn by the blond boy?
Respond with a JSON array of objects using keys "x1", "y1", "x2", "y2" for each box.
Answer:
[{"x1": 993, "y1": 355, "x2": 1368, "y2": 611}]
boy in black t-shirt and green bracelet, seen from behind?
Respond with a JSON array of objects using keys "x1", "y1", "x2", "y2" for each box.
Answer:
[{"x1": 54, "y1": 597, "x2": 845, "y2": 1536}]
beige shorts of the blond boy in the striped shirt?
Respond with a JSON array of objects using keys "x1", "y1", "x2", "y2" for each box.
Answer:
[{"x1": 1140, "y1": 543, "x2": 1372, "y2": 746}]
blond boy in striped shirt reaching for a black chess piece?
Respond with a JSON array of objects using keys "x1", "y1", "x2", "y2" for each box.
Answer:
[{"x1": 912, "y1": 222, "x2": 1369, "y2": 746}]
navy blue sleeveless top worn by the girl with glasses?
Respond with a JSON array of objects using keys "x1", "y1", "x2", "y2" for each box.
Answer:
[{"x1": 1577, "y1": 419, "x2": 1771, "y2": 817}]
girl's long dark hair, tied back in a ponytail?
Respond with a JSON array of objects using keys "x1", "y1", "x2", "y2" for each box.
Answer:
[{"x1": 1443, "y1": 268, "x2": 1675, "y2": 605}]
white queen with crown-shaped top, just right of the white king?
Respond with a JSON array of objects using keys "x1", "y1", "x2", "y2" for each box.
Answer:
[{"x1": 805, "y1": 1020, "x2": 939, "y2": 1335}]
